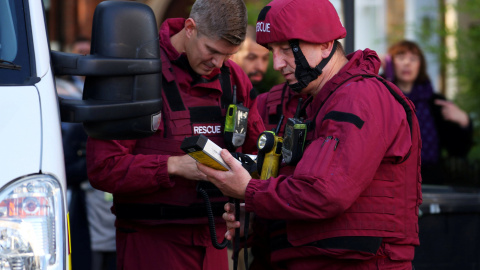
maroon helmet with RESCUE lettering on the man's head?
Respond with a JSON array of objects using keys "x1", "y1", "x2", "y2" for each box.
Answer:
[{"x1": 257, "y1": 0, "x2": 347, "y2": 47}]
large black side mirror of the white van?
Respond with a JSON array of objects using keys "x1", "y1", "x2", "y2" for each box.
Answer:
[{"x1": 51, "y1": 1, "x2": 162, "y2": 140}]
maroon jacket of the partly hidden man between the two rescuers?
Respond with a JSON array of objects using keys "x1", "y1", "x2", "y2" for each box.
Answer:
[{"x1": 257, "y1": 83, "x2": 306, "y2": 136}]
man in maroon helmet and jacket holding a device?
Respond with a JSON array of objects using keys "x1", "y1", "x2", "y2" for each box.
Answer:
[{"x1": 197, "y1": 0, "x2": 422, "y2": 270}]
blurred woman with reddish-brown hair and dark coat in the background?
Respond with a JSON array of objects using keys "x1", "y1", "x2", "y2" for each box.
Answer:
[{"x1": 383, "y1": 40, "x2": 473, "y2": 184}]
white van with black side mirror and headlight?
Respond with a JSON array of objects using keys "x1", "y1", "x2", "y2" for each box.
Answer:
[{"x1": 0, "y1": 0, "x2": 161, "y2": 270}]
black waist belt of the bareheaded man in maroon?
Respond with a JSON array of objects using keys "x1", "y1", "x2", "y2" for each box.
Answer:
[{"x1": 114, "y1": 202, "x2": 225, "y2": 220}]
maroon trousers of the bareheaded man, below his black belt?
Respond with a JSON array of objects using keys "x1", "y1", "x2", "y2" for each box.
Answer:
[{"x1": 117, "y1": 224, "x2": 228, "y2": 270}]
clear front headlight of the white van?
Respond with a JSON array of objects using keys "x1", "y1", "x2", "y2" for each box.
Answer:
[{"x1": 0, "y1": 175, "x2": 65, "y2": 270}]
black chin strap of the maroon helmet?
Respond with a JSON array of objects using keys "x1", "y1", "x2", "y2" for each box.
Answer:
[{"x1": 289, "y1": 39, "x2": 337, "y2": 93}]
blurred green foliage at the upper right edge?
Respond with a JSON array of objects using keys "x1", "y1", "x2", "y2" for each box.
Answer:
[{"x1": 417, "y1": 0, "x2": 480, "y2": 162}]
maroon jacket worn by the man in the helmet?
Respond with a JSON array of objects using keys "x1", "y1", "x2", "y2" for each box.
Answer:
[{"x1": 245, "y1": 49, "x2": 422, "y2": 261}]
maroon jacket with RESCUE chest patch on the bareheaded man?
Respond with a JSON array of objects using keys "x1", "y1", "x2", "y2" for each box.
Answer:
[{"x1": 87, "y1": 19, "x2": 265, "y2": 227}]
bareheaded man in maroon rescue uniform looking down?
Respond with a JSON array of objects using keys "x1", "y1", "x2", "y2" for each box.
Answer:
[{"x1": 87, "y1": 0, "x2": 264, "y2": 270}]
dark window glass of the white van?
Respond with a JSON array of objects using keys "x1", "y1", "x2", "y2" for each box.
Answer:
[{"x1": 0, "y1": 0, "x2": 31, "y2": 85}]
